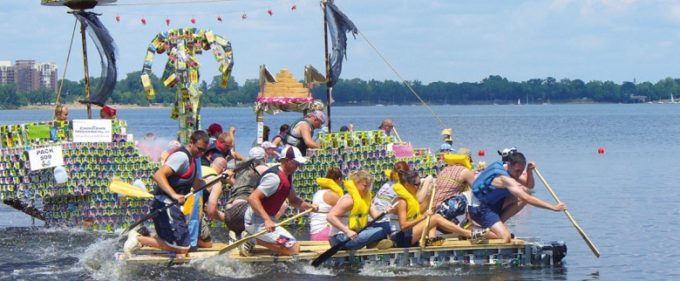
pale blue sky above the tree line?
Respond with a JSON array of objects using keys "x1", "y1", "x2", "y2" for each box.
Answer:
[{"x1": 0, "y1": 0, "x2": 680, "y2": 83}]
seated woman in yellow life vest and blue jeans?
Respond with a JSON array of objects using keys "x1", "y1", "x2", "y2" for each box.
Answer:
[{"x1": 326, "y1": 170, "x2": 392, "y2": 250}]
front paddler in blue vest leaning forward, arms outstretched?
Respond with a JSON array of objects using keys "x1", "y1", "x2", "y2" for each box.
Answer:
[{"x1": 470, "y1": 150, "x2": 567, "y2": 243}]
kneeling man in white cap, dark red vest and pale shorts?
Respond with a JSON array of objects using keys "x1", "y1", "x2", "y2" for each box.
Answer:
[{"x1": 239, "y1": 146, "x2": 318, "y2": 256}]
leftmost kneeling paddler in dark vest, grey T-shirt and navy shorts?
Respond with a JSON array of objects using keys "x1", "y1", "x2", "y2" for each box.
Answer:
[{"x1": 123, "y1": 131, "x2": 209, "y2": 256}]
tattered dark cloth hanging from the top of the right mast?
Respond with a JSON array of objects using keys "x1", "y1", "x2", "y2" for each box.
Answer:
[{"x1": 326, "y1": 2, "x2": 359, "y2": 87}]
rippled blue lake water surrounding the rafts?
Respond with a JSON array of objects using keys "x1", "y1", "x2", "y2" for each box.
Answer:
[{"x1": 0, "y1": 104, "x2": 680, "y2": 281}]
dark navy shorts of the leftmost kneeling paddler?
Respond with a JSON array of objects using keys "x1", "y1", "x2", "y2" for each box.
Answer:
[{"x1": 151, "y1": 195, "x2": 191, "y2": 250}]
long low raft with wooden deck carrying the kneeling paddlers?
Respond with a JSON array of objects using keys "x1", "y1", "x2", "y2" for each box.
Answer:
[{"x1": 118, "y1": 238, "x2": 567, "y2": 267}]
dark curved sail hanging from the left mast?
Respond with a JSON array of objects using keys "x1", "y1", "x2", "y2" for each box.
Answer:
[{"x1": 73, "y1": 11, "x2": 117, "y2": 106}]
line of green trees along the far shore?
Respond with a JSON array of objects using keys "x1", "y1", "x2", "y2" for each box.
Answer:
[{"x1": 0, "y1": 71, "x2": 680, "y2": 109}]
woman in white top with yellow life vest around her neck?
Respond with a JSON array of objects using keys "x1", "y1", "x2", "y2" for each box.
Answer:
[{"x1": 309, "y1": 167, "x2": 345, "y2": 241}]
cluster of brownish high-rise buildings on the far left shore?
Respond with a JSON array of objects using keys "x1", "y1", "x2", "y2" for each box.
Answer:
[{"x1": 0, "y1": 60, "x2": 58, "y2": 92}]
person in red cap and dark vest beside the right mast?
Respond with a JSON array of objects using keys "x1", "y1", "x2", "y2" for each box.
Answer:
[{"x1": 283, "y1": 110, "x2": 326, "y2": 155}]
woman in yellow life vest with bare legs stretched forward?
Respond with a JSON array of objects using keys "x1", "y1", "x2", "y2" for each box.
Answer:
[{"x1": 392, "y1": 170, "x2": 470, "y2": 248}]
